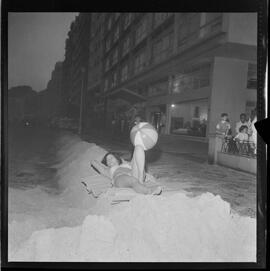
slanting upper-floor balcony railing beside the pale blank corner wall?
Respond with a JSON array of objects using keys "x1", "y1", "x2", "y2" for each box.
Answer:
[{"x1": 178, "y1": 16, "x2": 222, "y2": 51}]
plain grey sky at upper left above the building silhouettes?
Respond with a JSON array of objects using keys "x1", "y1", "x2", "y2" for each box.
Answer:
[{"x1": 8, "y1": 12, "x2": 78, "y2": 91}]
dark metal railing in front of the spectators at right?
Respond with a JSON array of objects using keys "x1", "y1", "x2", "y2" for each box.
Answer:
[{"x1": 221, "y1": 138, "x2": 257, "y2": 158}]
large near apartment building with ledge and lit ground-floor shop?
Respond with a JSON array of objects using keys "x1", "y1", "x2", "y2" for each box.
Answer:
[{"x1": 89, "y1": 13, "x2": 257, "y2": 142}]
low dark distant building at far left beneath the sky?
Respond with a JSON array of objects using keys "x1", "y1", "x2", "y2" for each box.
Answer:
[{"x1": 8, "y1": 86, "x2": 38, "y2": 123}]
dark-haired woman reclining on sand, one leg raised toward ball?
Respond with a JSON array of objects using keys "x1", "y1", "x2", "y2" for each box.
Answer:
[{"x1": 91, "y1": 145, "x2": 162, "y2": 195}]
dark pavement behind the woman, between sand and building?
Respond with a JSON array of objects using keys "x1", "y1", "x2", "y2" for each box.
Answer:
[{"x1": 84, "y1": 130, "x2": 256, "y2": 217}]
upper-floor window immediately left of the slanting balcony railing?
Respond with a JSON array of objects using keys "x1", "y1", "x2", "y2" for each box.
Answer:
[{"x1": 153, "y1": 33, "x2": 173, "y2": 63}]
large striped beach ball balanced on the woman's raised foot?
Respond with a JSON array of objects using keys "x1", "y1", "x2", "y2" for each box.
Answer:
[{"x1": 130, "y1": 122, "x2": 158, "y2": 150}]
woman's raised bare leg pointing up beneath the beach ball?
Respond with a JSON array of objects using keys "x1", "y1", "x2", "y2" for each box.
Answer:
[{"x1": 131, "y1": 145, "x2": 145, "y2": 184}]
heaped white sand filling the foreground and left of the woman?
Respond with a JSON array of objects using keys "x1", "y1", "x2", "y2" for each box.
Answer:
[{"x1": 9, "y1": 134, "x2": 256, "y2": 262}]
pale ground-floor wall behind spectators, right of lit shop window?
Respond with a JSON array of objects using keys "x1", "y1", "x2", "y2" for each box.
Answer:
[{"x1": 209, "y1": 57, "x2": 255, "y2": 137}]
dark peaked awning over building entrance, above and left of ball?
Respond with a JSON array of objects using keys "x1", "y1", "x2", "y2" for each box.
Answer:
[{"x1": 107, "y1": 88, "x2": 146, "y2": 104}]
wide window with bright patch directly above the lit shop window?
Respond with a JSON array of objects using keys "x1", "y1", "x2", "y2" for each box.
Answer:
[{"x1": 172, "y1": 64, "x2": 210, "y2": 93}]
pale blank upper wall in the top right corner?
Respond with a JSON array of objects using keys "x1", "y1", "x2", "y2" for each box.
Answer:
[{"x1": 226, "y1": 13, "x2": 257, "y2": 45}]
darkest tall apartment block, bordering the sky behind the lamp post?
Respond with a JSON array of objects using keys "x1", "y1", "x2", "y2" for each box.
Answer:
[{"x1": 62, "y1": 13, "x2": 91, "y2": 119}]
